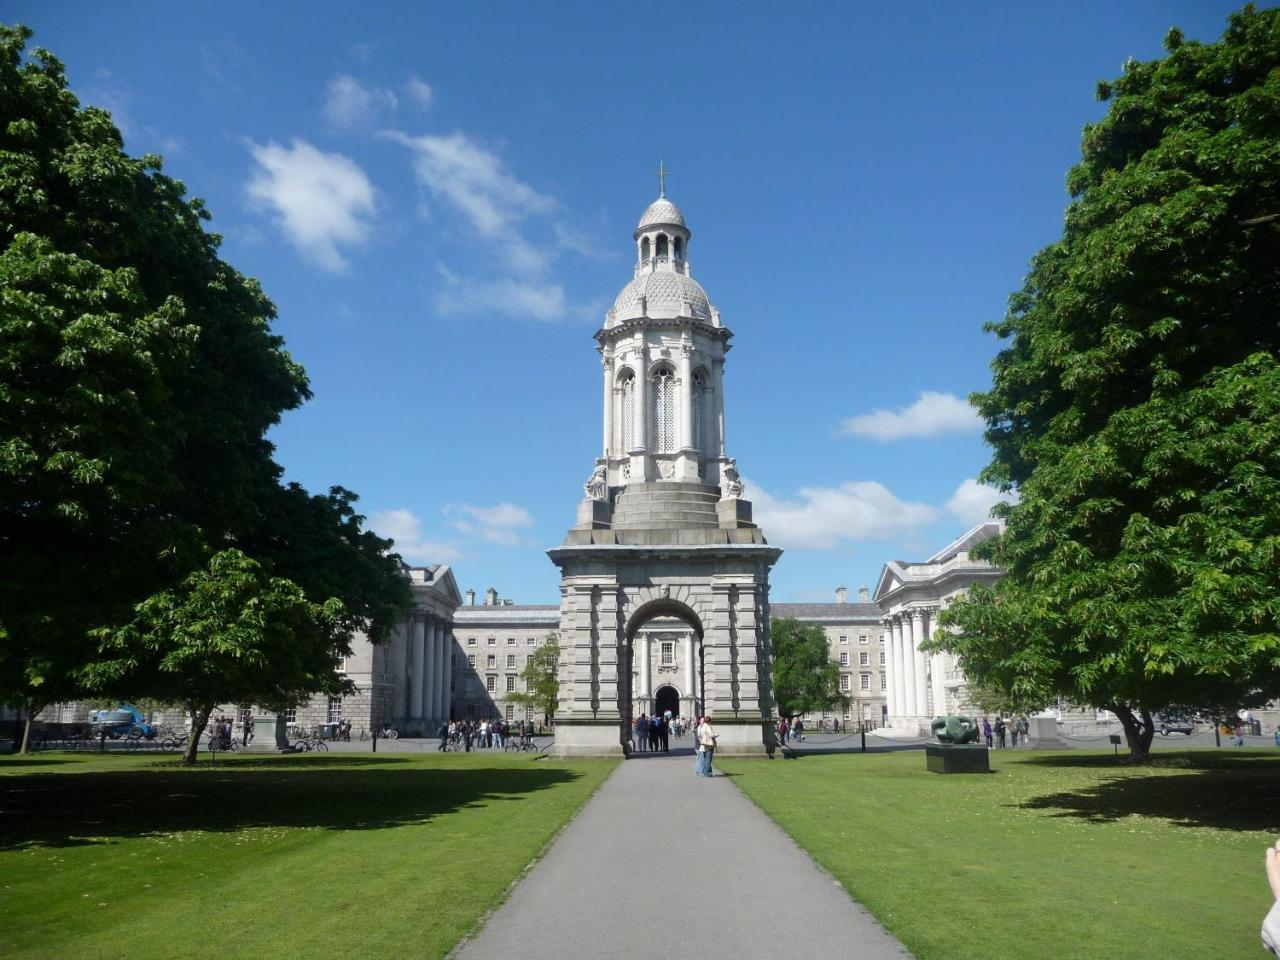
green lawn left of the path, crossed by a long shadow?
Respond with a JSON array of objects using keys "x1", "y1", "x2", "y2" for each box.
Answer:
[{"x1": 0, "y1": 753, "x2": 613, "y2": 960}]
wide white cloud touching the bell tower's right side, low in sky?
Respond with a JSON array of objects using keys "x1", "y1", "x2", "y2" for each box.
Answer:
[{"x1": 748, "y1": 480, "x2": 940, "y2": 550}]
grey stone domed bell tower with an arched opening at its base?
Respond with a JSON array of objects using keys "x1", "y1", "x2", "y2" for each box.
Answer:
[{"x1": 548, "y1": 181, "x2": 782, "y2": 755}]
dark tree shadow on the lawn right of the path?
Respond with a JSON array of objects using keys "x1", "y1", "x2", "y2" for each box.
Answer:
[{"x1": 1019, "y1": 753, "x2": 1280, "y2": 832}]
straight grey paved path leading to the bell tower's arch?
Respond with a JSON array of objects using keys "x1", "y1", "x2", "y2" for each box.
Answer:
[{"x1": 453, "y1": 751, "x2": 910, "y2": 960}]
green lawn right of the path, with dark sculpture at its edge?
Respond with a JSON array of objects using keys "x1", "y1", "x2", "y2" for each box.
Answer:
[{"x1": 717, "y1": 750, "x2": 1280, "y2": 960}]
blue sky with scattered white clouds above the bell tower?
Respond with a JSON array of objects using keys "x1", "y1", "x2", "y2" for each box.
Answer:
[{"x1": 12, "y1": 0, "x2": 1235, "y2": 603}]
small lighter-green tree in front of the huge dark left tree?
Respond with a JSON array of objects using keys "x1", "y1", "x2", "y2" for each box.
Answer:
[{"x1": 87, "y1": 550, "x2": 351, "y2": 763}]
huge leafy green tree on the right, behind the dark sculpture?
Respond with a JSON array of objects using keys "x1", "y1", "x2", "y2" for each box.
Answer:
[{"x1": 936, "y1": 6, "x2": 1280, "y2": 762}]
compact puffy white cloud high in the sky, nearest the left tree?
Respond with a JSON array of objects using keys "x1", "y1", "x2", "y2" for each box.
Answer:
[{"x1": 248, "y1": 138, "x2": 376, "y2": 273}]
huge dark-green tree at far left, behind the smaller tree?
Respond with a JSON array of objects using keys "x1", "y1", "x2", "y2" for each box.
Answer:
[{"x1": 0, "y1": 26, "x2": 407, "y2": 752}]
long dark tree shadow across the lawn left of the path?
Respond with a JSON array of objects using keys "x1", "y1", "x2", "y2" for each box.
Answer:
[{"x1": 0, "y1": 756, "x2": 579, "y2": 850}]
